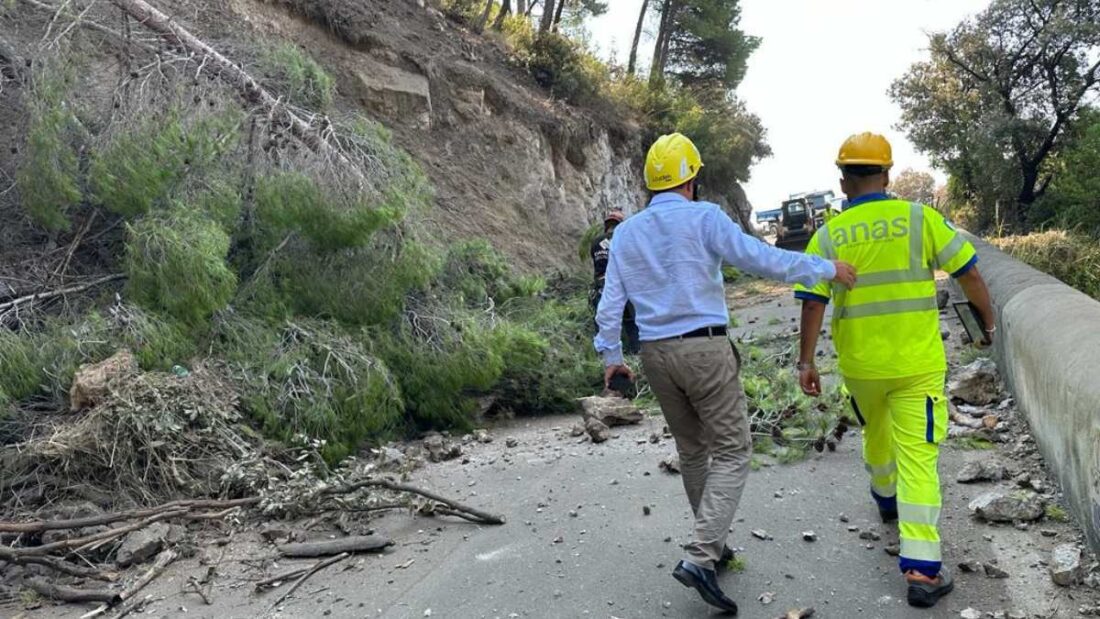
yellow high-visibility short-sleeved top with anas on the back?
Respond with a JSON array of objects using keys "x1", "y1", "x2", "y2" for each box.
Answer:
[{"x1": 794, "y1": 194, "x2": 978, "y2": 379}]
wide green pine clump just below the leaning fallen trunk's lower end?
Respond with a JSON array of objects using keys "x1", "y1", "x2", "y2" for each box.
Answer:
[{"x1": 255, "y1": 173, "x2": 404, "y2": 250}]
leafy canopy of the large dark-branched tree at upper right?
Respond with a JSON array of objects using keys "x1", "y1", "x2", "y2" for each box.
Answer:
[{"x1": 890, "y1": 0, "x2": 1100, "y2": 224}]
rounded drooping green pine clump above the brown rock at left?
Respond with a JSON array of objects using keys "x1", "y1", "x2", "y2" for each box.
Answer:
[{"x1": 125, "y1": 207, "x2": 237, "y2": 327}]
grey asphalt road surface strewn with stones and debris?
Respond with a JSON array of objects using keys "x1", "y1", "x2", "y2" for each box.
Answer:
[{"x1": 15, "y1": 288, "x2": 1096, "y2": 619}]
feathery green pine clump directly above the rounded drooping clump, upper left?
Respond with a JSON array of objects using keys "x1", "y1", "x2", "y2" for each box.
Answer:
[{"x1": 88, "y1": 112, "x2": 239, "y2": 219}]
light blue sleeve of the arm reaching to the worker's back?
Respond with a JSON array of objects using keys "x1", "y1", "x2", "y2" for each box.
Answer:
[{"x1": 707, "y1": 209, "x2": 836, "y2": 287}]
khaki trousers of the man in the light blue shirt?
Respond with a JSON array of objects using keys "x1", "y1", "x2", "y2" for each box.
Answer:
[{"x1": 641, "y1": 335, "x2": 752, "y2": 568}]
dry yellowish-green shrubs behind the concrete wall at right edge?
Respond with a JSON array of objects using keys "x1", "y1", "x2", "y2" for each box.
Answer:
[{"x1": 992, "y1": 230, "x2": 1100, "y2": 299}]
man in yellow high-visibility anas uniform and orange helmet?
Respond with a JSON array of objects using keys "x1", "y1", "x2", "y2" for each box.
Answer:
[{"x1": 795, "y1": 133, "x2": 996, "y2": 607}]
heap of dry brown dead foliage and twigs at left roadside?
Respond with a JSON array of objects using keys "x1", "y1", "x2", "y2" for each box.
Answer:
[{"x1": 0, "y1": 366, "x2": 279, "y2": 508}]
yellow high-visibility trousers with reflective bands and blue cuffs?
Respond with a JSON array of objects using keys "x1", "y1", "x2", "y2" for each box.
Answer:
[{"x1": 844, "y1": 372, "x2": 947, "y2": 578}]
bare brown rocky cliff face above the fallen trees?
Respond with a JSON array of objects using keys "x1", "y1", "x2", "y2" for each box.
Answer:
[{"x1": 231, "y1": 0, "x2": 647, "y2": 269}]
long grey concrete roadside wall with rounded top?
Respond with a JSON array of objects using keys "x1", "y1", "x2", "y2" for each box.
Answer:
[{"x1": 970, "y1": 237, "x2": 1100, "y2": 551}]
